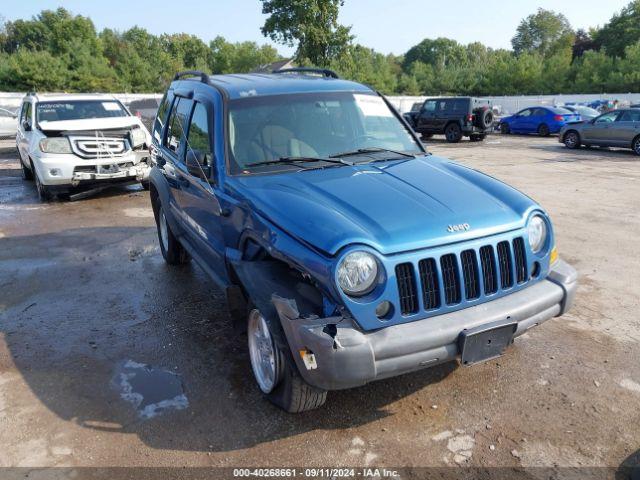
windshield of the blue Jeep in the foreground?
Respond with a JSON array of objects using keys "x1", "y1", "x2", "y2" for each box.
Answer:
[{"x1": 229, "y1": 92, "x2": 424, "y2": 174}]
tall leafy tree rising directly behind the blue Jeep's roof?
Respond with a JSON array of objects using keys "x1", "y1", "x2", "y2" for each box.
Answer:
[{"x1": 261, "y1": 0, "x2": 353, "y2": 67}]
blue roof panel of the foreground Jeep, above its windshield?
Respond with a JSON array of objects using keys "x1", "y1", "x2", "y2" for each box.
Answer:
[{"x1": 202, "y1": 73, "x2": 372, "y2": 99}]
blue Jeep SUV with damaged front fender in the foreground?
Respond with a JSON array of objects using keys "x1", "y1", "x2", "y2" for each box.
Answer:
[{"x1": 150, "y1": 69, "x2": 577, "y2": 412}]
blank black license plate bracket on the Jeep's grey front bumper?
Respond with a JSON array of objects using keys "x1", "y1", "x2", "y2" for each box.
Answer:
[{"x1": 458, "y1": 319, "x2": 518, "y2": 366}]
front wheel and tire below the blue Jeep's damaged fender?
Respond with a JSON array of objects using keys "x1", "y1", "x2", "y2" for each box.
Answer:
[{"x1": 247, "y1": 309, "x2": 327, "y2": 413}]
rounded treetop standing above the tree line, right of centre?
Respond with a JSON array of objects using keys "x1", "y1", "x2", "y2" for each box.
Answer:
[{"x1": 511, "y1": 8, "x2": 575, "y2": 56}]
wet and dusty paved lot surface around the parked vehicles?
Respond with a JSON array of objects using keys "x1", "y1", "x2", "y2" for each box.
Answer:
[{"x1": 0, "y1": 136, "x2": 640, "y2": 476}]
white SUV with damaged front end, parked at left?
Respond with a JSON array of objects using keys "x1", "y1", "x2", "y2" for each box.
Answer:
[{"x1": 16, "y1": 94, "x2": 151, "y2": 201}]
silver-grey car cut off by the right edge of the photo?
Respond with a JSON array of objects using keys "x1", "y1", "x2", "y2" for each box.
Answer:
[{"x1": 558, "y1": 108, "x2": 640, "y2": 155}]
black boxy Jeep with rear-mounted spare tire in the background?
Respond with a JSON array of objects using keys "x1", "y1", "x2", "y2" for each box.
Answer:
[{"x1": 404, "y1": 97, "x2": 494, "y2": 143}]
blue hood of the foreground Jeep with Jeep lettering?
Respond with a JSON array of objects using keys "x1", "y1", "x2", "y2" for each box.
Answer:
[{"x1": 234, "y1": 156, "x2": 537, "y2": 255}]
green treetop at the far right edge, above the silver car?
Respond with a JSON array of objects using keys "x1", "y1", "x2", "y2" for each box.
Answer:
[{"x1": 594, "y1": 0, "x2": 640, "y2": 57}]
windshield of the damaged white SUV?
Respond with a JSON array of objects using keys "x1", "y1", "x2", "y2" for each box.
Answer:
[{"x1": 36, "y1": 100, "x2": 127, "y2": 122}]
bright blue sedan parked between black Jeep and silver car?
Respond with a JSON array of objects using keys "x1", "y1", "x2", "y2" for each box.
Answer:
[{"x1": 500, "y1": 107, "x2": 582, "y2": 137}]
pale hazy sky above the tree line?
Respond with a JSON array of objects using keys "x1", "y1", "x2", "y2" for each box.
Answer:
[{"x1": 0, "y1": 0, "x2": 630, "y2": 55}]
